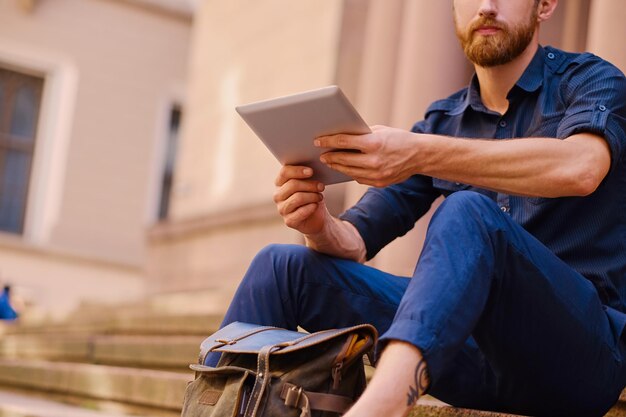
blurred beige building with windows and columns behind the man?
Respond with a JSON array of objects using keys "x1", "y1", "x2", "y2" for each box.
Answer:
[{"x1": 0, "y1": 0, "x2": 626, "y2": 415}]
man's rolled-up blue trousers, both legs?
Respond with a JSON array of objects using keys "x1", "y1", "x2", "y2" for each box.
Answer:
[{"x1": 207, "y1": 192, "x2": 626, "y2": 417}]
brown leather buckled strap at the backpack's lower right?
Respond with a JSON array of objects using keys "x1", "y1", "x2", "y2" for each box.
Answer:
[{"x1": 280, "y1": 383, "x2": 354, "y2": 417}]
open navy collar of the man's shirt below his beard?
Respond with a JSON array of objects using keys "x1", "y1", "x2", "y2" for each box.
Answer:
[{"x1": 448, "y1": 46, "x2": 545, "y2": 116}]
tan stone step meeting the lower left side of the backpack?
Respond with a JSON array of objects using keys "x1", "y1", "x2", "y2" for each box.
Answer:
[{"x1": 0, "y1": 359, "x2": 193, "y2": 410}]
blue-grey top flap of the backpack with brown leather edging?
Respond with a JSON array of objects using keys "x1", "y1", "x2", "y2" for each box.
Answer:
[{"x1": 201, "y1": 322, "x2": 378, "y2": 356}]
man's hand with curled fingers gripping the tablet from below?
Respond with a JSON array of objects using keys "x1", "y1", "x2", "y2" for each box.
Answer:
[{"x1": 274, "y1": 165, "x2": 332, "y2": 235}]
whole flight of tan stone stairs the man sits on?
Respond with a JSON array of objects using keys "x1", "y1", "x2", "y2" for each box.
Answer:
[{"x1": 0, "y1": 312, "x2": 626, "y2": 417}]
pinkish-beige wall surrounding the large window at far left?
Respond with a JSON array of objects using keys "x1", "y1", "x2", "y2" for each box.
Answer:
[{"x1": 0, "y1": 0, "x2": 190, "y2": 266}]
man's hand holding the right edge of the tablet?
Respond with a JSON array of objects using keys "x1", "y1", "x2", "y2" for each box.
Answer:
[{"x1": 315, "y1": 126, "x2": 419, "y2": 187}]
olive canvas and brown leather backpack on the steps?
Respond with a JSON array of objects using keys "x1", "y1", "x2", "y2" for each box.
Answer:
[{"x1": 182, "y1": 322, "x2": 378, "y2": 417}]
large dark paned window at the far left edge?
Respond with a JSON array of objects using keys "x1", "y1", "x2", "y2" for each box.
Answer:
[{"x1": 0, "y1": 68, "x2": 44, "y2": 234}]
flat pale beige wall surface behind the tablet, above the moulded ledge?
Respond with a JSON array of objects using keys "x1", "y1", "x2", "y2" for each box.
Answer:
[{"x1": 172, "y1": 0, "x2": 341, "y2": 219}]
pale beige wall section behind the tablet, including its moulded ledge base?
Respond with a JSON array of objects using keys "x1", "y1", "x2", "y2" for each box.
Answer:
[{"x1": 148, "y1": 0, "x2": 342, "y2": 298}]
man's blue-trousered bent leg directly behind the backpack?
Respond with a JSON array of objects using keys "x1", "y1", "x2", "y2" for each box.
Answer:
[{"x1": 207, "y1": 245, "x2": 409, "y2": 366}]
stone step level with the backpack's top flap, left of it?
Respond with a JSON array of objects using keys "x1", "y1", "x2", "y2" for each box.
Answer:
[{"x1": 0, "y1": 333, "x2": 206, "y2": 370}]
